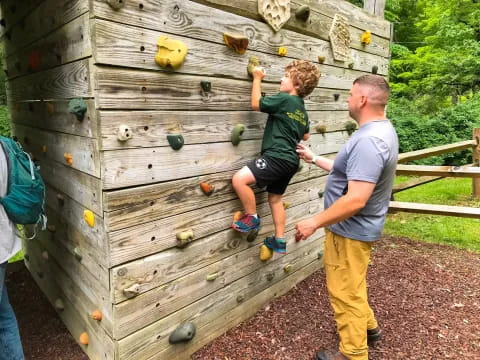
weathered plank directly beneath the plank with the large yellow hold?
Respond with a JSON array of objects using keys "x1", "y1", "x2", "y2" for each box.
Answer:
[{"x1": 94, "y1": 66, "x2": 348, "y2": 111}]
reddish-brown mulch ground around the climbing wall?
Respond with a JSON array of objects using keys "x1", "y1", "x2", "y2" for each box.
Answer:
[{"x1": 7, "y1": 237, "x2": 480, "y2": 360}]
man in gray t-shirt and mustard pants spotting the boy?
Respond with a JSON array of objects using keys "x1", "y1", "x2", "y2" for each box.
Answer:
[{"x1": 296, "y1": 75, "x2": 398, "y2": 360}]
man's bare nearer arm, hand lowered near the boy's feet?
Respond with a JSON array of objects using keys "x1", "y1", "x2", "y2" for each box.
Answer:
[{"x1": 295, "y1": 180, "x2": 375, "y2": 241}]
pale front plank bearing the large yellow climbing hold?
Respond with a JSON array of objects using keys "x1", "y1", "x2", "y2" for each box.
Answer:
[{"x1": 94, "y1": 20, "x2": 388, "y2": 90}]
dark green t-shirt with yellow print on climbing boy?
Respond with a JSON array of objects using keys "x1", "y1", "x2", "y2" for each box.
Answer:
[{"x1": 260, "y1": 92, "x2": 310, "y2": 164}]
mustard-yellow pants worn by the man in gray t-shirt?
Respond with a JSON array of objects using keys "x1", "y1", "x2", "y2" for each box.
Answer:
[{"x1": 324, "y1": 230, "x2": 378, "y2": 360}]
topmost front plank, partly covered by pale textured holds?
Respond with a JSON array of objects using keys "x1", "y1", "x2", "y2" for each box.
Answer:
[{"x1": 189, "y1": 0, "x2": 389, "y2": 57}]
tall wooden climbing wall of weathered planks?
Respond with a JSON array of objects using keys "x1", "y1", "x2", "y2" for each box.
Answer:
[{"x1": 0, "y1": 0, "x2": 390, "y2": 360}]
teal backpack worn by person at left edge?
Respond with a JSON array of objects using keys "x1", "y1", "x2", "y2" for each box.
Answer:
[{"x1": 0, "y1": 136, "x2": 47, "y2": 236}]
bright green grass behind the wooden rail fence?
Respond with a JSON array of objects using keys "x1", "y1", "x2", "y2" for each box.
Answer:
[{"x1": 384, "y1": 176, "x2": 480, "y2": 253}]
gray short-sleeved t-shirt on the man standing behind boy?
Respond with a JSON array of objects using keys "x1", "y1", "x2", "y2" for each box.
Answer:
[{"x1": 324, "y1": 120, "x2": 398, "y2": 241}]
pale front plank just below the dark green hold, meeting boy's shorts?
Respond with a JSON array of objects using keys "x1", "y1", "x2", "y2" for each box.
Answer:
[{"x1": 102, "y1": 132, "x2": 348, "y2": 189}]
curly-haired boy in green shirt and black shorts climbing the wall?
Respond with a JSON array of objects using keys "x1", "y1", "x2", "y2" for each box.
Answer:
[{"x1": 232, "y1": 60, "x2": 320, "y2": 254}]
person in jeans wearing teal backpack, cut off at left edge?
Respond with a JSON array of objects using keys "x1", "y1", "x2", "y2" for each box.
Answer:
[{"x1": 0, "y1": 146, "x2": 24, "y2": 360}]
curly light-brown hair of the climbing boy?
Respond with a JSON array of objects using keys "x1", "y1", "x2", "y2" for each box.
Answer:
[{"x1": 285, "y1": 60, "x2": 321, "y2": 98}]
